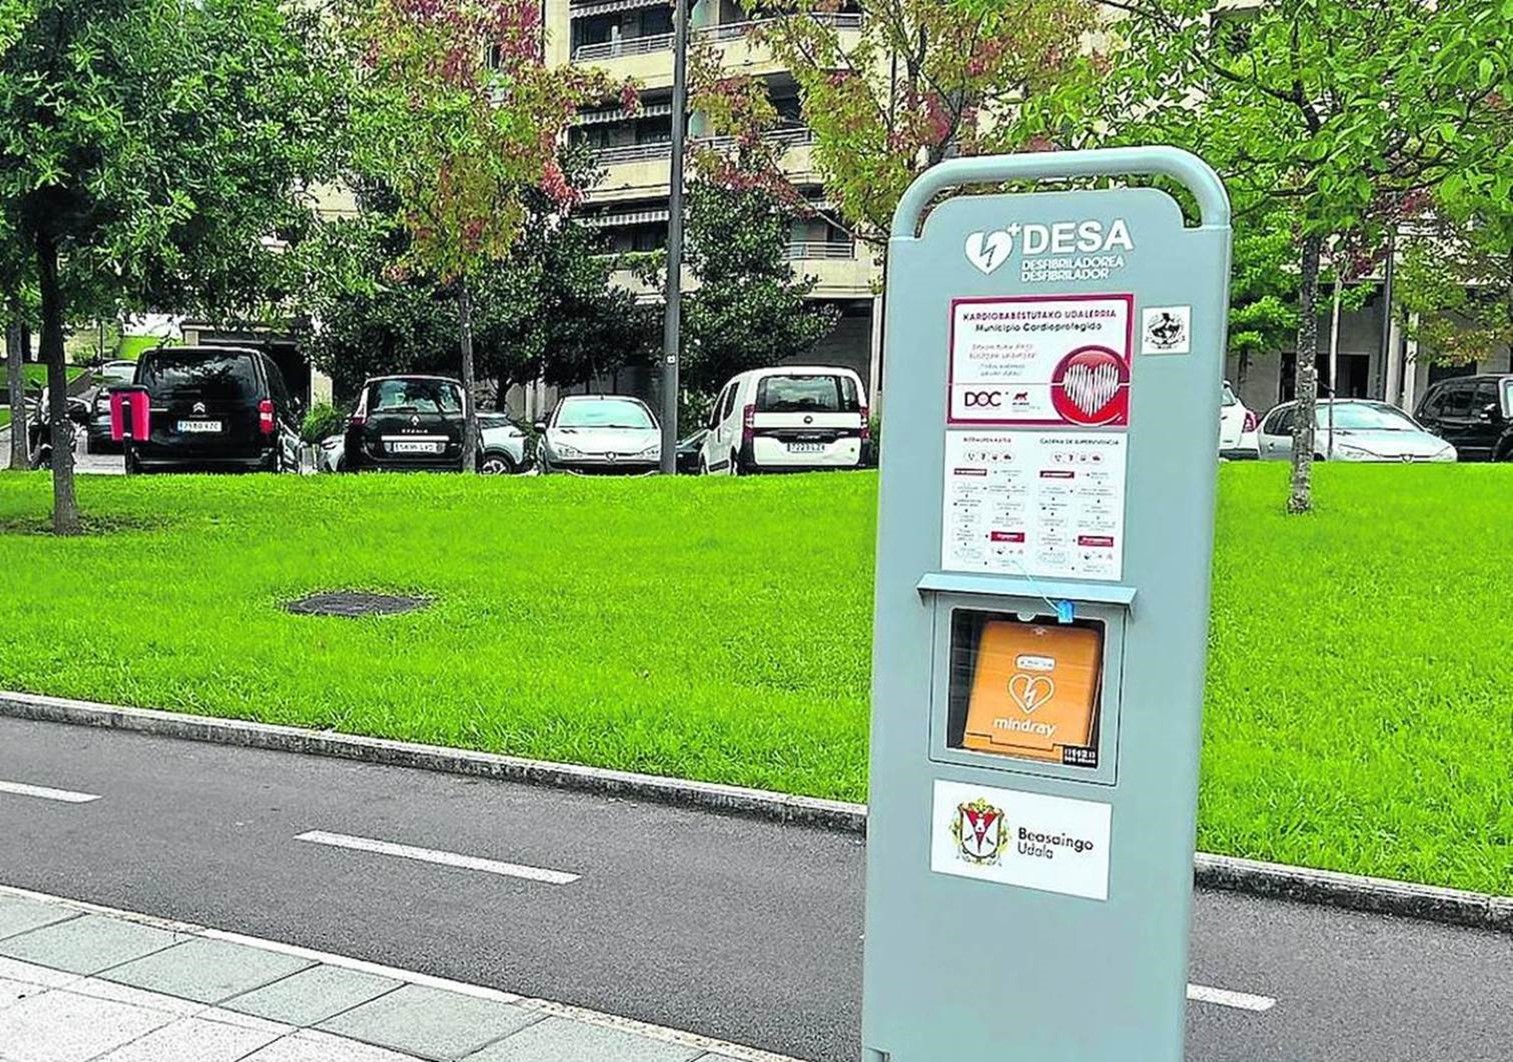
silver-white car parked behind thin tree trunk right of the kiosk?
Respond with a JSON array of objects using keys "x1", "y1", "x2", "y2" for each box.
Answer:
[{"x1": 1260, "y1": 398, "x2": 1456, "y2": 461}]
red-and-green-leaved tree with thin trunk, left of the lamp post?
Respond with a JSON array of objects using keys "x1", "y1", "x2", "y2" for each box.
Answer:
[{"x1": 343, "y1": 0, "x2": 607, "y2": 475}]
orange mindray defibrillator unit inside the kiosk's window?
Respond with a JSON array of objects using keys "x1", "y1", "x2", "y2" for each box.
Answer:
[{"x1": 962, "y1": 619, "x2": 1103, "y2": 767}]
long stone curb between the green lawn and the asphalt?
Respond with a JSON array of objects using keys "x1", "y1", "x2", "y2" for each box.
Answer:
[{"x1": 0, "y1": 693, "x2": 1513, "y2": 933}]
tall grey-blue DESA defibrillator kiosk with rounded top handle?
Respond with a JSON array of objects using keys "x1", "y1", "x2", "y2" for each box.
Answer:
[{"x1": 861, "y1": 147, "x2": 1230, "y2": 1062}]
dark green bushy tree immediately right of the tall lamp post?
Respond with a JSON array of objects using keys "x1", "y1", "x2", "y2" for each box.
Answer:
[{"x1": 681, "y1": 182, "x2": 837, "y2": 393}]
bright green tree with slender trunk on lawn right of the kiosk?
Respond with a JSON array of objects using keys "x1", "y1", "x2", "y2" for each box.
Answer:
[{"x1": 1070, "y1": 0, "x2": 1513, "y2": 513}]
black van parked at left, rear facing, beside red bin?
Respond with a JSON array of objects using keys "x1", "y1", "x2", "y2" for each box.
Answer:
[{"x1": 126, "y1": 346, "x2": 300, "y2": 472}]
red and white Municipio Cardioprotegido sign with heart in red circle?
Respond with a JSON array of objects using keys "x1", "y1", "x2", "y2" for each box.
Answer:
[{"x1": 947, "y1": 295, "x2": 1135, "y2": 428}]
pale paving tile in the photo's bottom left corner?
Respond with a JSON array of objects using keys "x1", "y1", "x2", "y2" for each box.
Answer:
[{"x1": 0, "y1": 991, "x2": 176, "y2": 1062}]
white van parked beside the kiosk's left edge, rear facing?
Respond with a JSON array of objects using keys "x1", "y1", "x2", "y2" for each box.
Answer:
[{"x1": 699, "y1": 365, "x2": 868, "y2": 475}]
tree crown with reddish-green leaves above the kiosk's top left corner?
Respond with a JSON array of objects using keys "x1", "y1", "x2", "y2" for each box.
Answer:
[{"x1": 729, "y1": 0, "x2": 1094, "y2": 245}]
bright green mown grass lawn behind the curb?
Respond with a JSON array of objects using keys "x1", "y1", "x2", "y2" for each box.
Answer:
[{"x1": 0, "y1": 464, "x2": 1513, "y2": 894}]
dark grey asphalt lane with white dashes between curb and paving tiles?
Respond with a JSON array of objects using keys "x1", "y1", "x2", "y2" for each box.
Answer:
[{"x1": 0, "y1": 719, "x2": 1513, "y2": 1062}]
